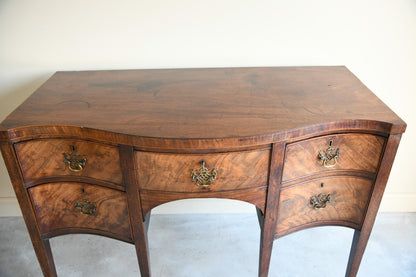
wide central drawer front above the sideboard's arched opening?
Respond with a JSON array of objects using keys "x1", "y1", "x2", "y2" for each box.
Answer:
[{"x1": 135, "y1": 149, "x2": 270, "y2": 192}]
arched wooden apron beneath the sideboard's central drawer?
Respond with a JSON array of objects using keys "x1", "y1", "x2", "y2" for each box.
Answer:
[{"x1": 140, "y1": 187, "x2": 267, "y2": 217}]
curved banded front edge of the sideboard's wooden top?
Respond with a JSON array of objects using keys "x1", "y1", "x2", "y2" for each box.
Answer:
[{"x1": 0, "y1": 120, "x2": 405, "y2": 150}]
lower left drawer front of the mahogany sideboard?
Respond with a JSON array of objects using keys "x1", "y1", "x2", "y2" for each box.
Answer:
[{"x1": 29, "y1": 182, "x2": 132, "y2": 240}]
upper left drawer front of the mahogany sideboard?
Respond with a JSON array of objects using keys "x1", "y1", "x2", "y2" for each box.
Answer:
[{"x1": 15, "y1": 139, "x2": 122, "y2": 185}]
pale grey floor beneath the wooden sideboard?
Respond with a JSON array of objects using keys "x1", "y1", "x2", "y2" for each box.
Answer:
[{"x1": 0, "y1": 213, "x2": 416, "y2": 277}]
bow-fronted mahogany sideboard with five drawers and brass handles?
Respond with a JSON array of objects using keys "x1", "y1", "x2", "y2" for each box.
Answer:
[{"x1": 0, "y1": 66, "x2": 406, "y2": 277}]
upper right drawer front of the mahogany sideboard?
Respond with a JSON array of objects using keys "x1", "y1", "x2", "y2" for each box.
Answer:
[{"x1": 282, "y1": 134, "x2": 385, "y2": 181}]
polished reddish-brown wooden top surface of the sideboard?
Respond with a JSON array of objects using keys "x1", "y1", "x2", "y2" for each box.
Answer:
[{"x1": 1, "y1": 66, "x2": 406, "y2": 139}]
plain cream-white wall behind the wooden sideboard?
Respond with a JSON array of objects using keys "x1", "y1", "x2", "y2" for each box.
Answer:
[{"x1": 0, "y1": 0, "x2": 416, "y2": 215}]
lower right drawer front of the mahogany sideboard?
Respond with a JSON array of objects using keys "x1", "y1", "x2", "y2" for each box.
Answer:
[{"x1": 276, "y1": 177, "x2": 372, "y2": 236}]
